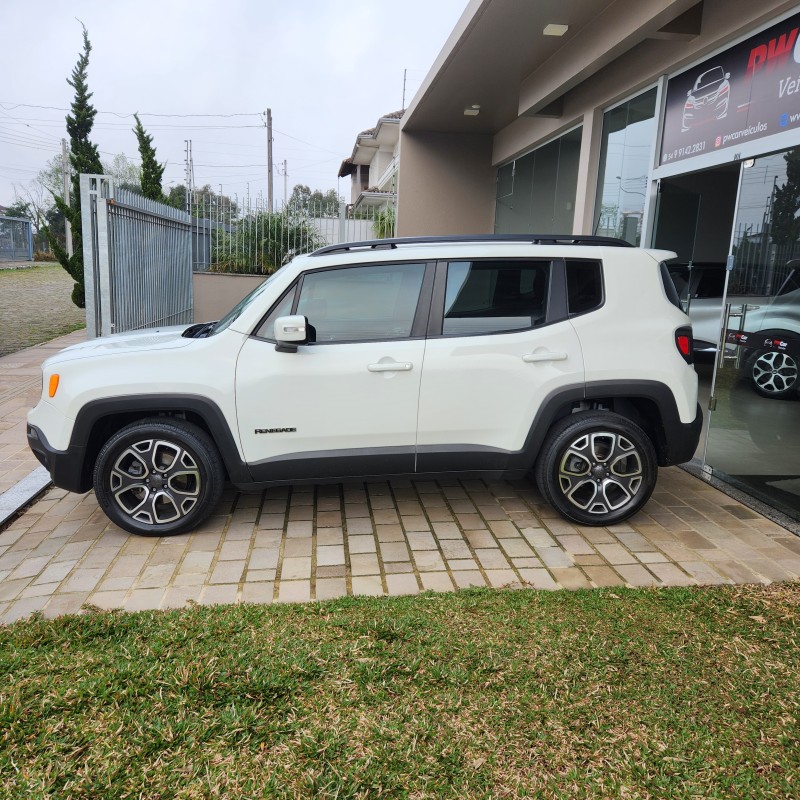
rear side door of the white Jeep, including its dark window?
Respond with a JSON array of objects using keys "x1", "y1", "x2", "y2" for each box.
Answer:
[{"x1": 417, "y1": 259, "x2": 584, "y2": 472}]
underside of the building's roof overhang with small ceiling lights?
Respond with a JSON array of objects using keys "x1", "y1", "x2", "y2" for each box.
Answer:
[{"x1": 402, "y1": 0, "x2": 703, "y2": 135}]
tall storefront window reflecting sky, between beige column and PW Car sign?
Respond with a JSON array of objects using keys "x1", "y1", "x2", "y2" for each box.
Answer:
[{"x1": 593, "y1": 88, "x2": 656, "y2": 246}]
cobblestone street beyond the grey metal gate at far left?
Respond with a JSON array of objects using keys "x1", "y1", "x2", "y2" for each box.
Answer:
[{"x1": 0, "y1": 262, "x2": 86, "y2": 356}]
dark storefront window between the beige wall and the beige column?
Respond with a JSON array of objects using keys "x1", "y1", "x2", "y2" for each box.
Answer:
[{"x1": 494, "y1": 128, "x2": 583, "y2": 233}]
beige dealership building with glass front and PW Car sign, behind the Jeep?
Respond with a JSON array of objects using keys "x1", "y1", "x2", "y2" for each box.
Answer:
[{"x1": 397, "y1": 0, "x2": 800, "y2": 520}]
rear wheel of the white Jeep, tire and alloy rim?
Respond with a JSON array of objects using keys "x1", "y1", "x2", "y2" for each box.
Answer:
[{"x1": 534, "y1": 411, "x2": 658, "y2": 525}]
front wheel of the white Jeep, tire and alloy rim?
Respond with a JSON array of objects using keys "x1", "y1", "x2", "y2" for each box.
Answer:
[{"x1": 94, "y1": 418, "x2": 225, "y2": 536}]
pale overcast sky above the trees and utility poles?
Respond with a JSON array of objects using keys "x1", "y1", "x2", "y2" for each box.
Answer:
[{"x1": 0, "y1": 0, "x2": 467, "y2": 205}]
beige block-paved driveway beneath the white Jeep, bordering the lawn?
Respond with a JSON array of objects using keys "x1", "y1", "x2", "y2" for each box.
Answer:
[{"x1": 0, "y1": 467, "x2": 800, "y2": 623}]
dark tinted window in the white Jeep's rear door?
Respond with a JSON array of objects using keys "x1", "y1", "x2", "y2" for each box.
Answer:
[{"x1": 442, "y1": 261, "x2": 550, "y2": 335}]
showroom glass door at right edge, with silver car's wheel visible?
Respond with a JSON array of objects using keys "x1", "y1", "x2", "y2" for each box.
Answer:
[{"x1": 705, "y1": 148, "x2": 800, "y2": 519}]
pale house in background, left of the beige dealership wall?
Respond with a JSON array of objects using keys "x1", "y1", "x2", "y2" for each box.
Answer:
[{"x1": 339, "y1": 111, "x2": 404, "y2": 210}]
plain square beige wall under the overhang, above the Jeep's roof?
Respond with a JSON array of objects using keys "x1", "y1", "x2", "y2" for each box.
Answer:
[{"x1": 397, "y1": 133, "x2": 495, "y2": 236}]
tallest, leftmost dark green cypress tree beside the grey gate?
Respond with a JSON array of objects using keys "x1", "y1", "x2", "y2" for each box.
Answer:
[{"x1": 43, "y1": 23, "x2": 103, "y2": 308}]
